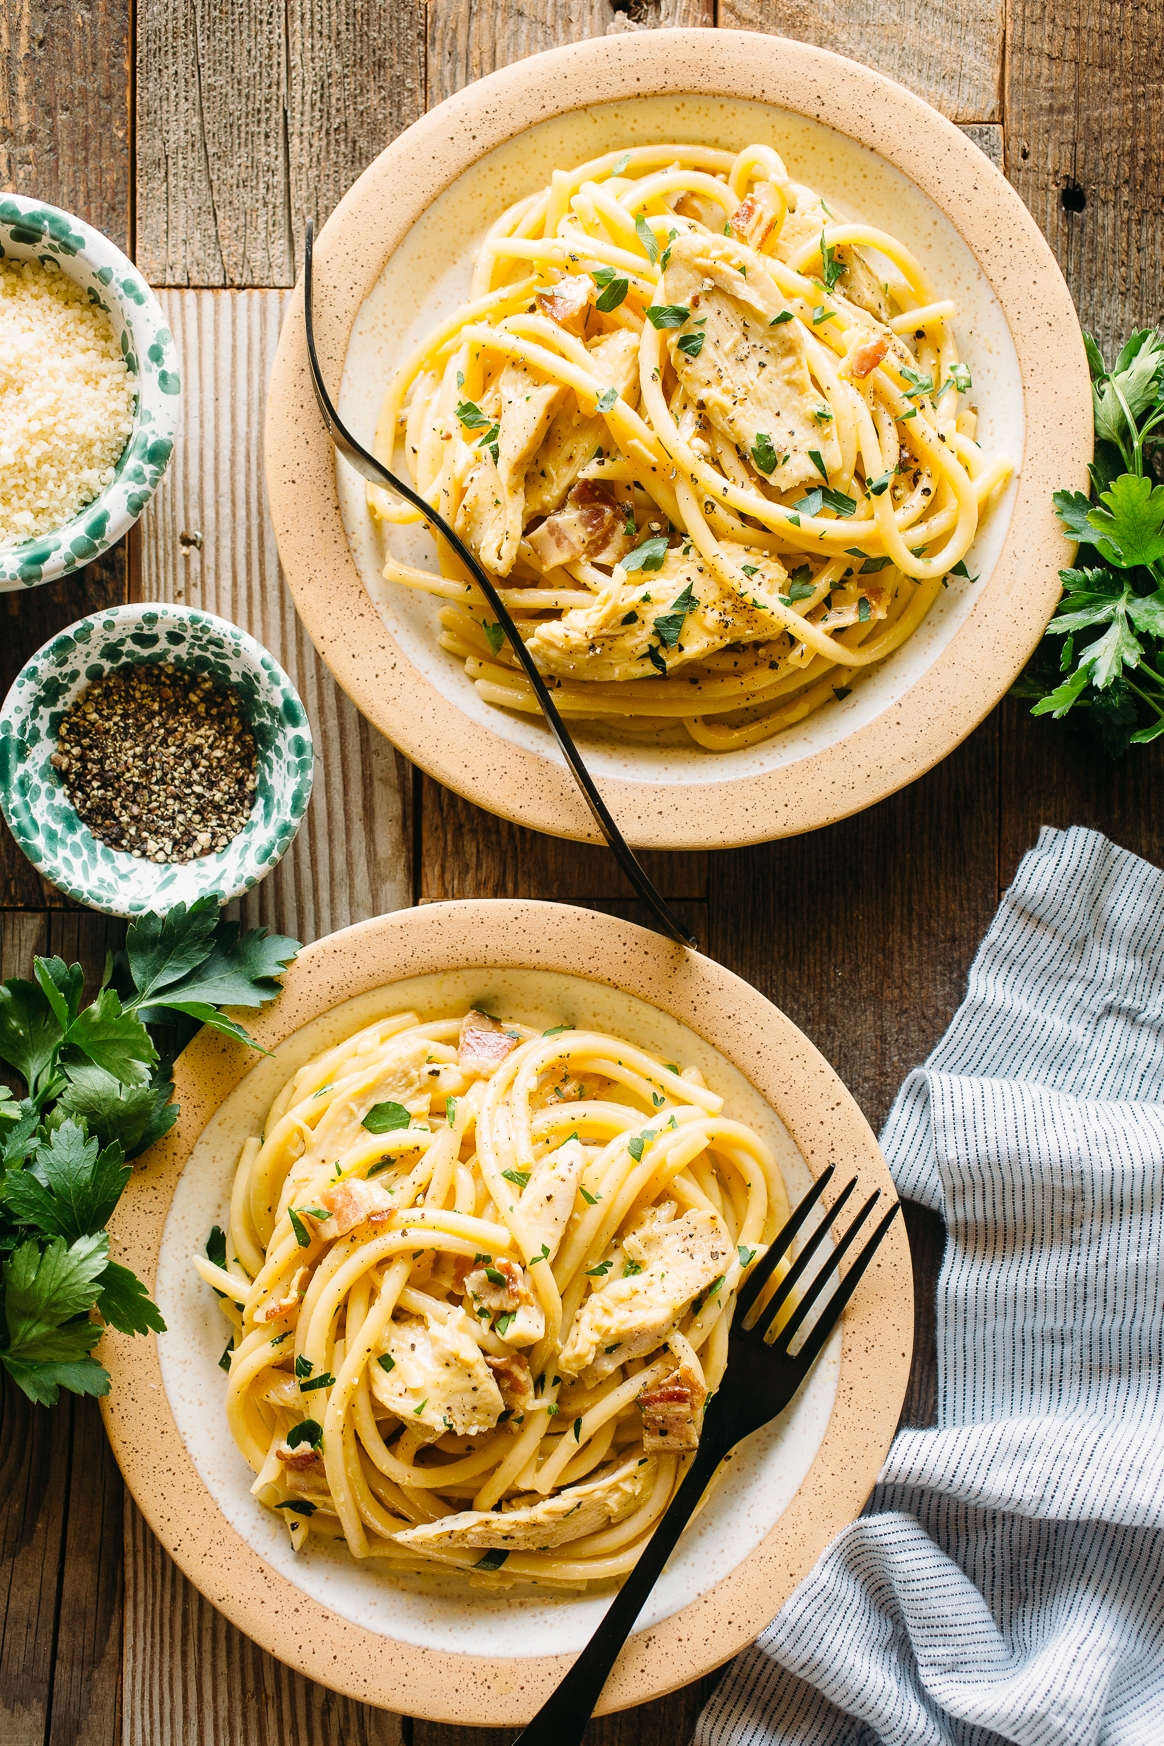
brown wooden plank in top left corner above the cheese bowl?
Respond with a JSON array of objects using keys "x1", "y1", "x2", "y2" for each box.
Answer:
[{"x1": 0, "y1": 0, "x2": 131, "y2": 248}]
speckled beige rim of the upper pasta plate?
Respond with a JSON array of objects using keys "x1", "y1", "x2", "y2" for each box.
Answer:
[{"x1": 265, "y1": 30, "x2": 1092, "y2": 849}]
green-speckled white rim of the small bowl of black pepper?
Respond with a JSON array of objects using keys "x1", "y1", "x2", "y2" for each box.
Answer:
[{"x1": 0, "y1": 602, "x2": 314, "y2": 915}]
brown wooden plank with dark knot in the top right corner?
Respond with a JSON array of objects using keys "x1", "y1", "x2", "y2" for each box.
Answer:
[{"x1": 1005, "y1": 0, "x2": 1164, "y2": 346}]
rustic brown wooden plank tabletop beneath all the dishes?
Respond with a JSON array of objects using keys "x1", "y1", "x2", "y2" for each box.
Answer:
[{"x1": 0, "y1": 0, "x2": 1164, "y2": 1746}]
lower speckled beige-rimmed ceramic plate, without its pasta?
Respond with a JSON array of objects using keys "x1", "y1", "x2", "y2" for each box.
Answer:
[{"x1": 98, "y1": 901, "x2": 913, "y2": 1727}]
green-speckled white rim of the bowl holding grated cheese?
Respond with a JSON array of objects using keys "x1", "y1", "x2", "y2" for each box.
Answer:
[{"x1": 0, "y1": 194, "x2": 181, "y2": 592}]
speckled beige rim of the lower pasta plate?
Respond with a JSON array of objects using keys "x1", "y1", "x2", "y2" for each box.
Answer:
[{"x1": 98, "y1": 899, "x2": 913, "y2": 1727}]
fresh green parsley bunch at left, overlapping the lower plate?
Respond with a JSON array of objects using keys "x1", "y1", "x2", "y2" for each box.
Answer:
[{"x1": 0, "y1": 897, "x2": 298, "y2": 1406}]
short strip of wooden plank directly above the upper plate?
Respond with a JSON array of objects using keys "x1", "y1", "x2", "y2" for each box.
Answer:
[{"x1": 426, "y1": 0, "x2": 722, "y2": 108}]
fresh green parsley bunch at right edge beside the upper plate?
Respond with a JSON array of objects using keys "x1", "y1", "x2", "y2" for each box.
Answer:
[{"x1": 1014, "y1": 328, "x2": 1164, "y2": 756}]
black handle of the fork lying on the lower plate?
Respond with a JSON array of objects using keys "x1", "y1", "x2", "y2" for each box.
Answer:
[{"x1": 513, "y1": 1425, "x2": 735, "y2": 1746}]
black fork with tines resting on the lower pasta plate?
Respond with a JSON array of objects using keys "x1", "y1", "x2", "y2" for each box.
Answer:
[{"x1": 513, "y1": 1165, "x2": 899, "y2": 1746}]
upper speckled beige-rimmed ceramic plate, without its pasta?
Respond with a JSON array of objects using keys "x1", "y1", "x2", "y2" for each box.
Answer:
[{"x1": 265, "y1": 30, "x2": 1091, "y2": 849}]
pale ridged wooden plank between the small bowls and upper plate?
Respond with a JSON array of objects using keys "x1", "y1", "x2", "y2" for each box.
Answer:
[{"x1": 141, "y1": 290, "x2": 412, "y2": 941}]
